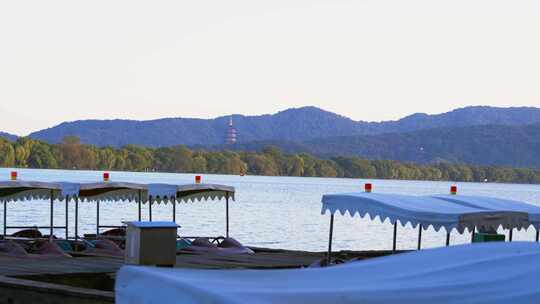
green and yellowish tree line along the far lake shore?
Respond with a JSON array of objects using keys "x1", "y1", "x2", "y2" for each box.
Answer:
[{"x1": 0, "y1": 136, "x2": 540, "y2": 184}]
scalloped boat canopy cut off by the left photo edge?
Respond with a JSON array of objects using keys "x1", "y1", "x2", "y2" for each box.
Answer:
[{"x1": 0, "y1": 180, "x2": 60, "y2": 202}]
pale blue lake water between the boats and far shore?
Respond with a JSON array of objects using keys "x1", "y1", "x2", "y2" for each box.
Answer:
[{"x1": 0, "y1": 169, "x2": 540, "y2": 251}]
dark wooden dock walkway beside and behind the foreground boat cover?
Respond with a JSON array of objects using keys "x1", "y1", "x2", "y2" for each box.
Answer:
[{"x1": 0, "y1": 248, "x2": 389, "y2": 304}]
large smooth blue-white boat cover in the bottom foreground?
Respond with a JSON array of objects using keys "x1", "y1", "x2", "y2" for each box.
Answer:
[{"x1": 115, "y1": 242, "x2": 540, "y2": 304}]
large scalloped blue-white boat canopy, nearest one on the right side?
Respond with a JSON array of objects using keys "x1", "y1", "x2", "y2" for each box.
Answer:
[{"x1": 321, "y1": 192, "x2": 529, "y2": 233}]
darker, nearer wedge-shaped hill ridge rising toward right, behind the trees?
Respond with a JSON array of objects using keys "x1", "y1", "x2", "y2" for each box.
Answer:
[{"x1": 206, "y1": 123, "x2": 540, "y2": 168}]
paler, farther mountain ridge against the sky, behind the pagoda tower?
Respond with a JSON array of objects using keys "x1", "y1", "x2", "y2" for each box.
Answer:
[{"x1": 29, "y1": 107, "x2": 540, "y2": 147}]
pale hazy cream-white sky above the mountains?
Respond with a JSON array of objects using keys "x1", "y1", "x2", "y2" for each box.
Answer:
[{"x1": 0, "y1": 0, "x2": 540, "y2": 135}]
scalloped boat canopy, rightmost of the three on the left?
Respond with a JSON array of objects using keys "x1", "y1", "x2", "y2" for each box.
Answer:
[{"x1": 148, "y1": 184, "x2": 235, "y2": 203}]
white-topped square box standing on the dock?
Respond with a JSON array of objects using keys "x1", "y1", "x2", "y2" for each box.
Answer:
[{"x1": 125, "y1": 222, "x2": 179, "y2": 266}]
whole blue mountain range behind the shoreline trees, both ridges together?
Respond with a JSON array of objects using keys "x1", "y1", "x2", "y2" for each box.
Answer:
[{"x1": 0, "y1": 106, "x2": 540, "y2": 168}]
